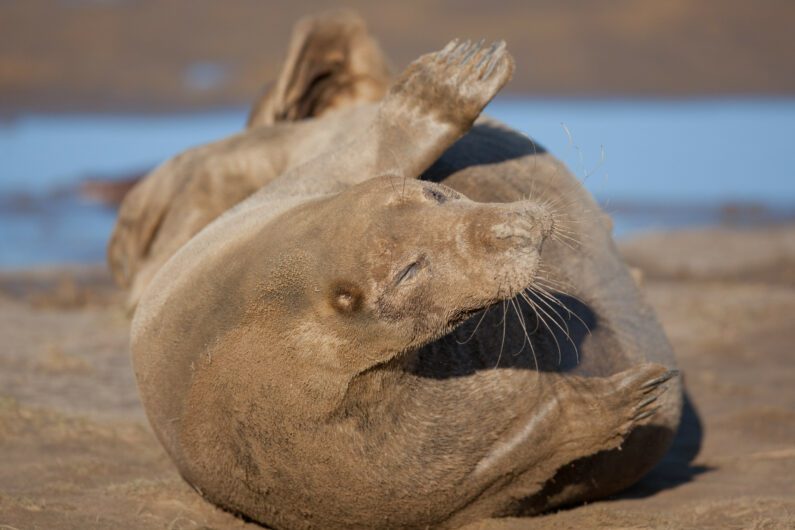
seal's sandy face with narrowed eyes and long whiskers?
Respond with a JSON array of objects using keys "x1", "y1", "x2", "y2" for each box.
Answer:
[{"x1": 262, "y1": 177, "x2": 554, "y2": 370}]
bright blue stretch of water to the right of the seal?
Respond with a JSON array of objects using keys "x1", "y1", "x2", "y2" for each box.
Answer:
[{"x1": 490, "y1": 100, "x2": 795, "y2": 204}]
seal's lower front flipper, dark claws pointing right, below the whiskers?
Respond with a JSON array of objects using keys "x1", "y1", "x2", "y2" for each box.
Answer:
[{"x1": 457, "y1": 364, "x2": 678, "y2": 521}]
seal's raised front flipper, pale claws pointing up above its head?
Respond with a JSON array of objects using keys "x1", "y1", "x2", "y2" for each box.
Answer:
[{"x1": 266, "y1": 41, "x2": 513, "y2": 194}]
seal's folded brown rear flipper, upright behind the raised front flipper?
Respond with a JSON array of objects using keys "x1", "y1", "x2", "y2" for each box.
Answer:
[{"x1": 248, "y1": 10, "x2": 390, "y2": 128}]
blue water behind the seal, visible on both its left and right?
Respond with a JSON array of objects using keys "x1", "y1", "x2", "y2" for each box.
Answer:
[{"x1": 0, "y1": 99, "x2": 795, "y2": 267}]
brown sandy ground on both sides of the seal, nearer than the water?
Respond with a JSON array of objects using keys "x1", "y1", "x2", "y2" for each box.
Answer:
[{"x1": 0, "y1": 226, "x2": 795, "y2": 530}]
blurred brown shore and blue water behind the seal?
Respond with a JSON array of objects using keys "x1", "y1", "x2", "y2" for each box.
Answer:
[{"x1": 0, "y1": 0, "x2": 795, "y2": 269}]
